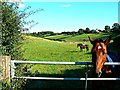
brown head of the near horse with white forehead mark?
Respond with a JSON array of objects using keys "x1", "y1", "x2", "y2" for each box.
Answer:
[{"x1": 89, "y1": 37, "x2": 111, "y2": 77}]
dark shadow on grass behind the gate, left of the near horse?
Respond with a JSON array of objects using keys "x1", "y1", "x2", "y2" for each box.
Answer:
[{"x1": 25, "y1": 68, "x2": 91, "y2": 90}]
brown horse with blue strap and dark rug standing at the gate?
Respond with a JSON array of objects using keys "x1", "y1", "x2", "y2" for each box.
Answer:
[{"x1": 88, "y1": 37, "x2": 120, "y2": 90}]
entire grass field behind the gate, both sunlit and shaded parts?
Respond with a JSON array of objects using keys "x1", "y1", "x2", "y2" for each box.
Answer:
[{"x1": 19, "y1": 33, "x2": 114, "y2": 90}]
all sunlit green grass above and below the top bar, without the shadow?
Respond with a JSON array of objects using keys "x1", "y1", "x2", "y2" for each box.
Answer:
[{"x1": 23, "y1": 33, "x2": 110, "y2": 74}]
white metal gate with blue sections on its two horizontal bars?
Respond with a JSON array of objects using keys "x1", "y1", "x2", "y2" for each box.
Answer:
[{"x1": 11, "y1": 60, "x2": 120, "y2": 80}]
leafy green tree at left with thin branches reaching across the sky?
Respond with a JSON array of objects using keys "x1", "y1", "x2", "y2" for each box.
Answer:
[{"x1": 0, "y1": 2, "x2": 41, "y2": 90}]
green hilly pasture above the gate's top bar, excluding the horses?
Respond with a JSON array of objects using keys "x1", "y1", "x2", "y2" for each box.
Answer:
[{"x1": 23, "y1": 34, "x2": 109, "y2": 62}]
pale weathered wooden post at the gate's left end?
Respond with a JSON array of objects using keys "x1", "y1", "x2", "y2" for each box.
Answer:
[{"x1": 0, "y1": 56, "x2": 11, "y2": 82}]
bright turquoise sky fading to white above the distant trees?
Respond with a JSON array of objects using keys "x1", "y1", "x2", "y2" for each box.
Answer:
[{"x1": 20, "y1": 2, "x2": 118, "y2": 33}]
